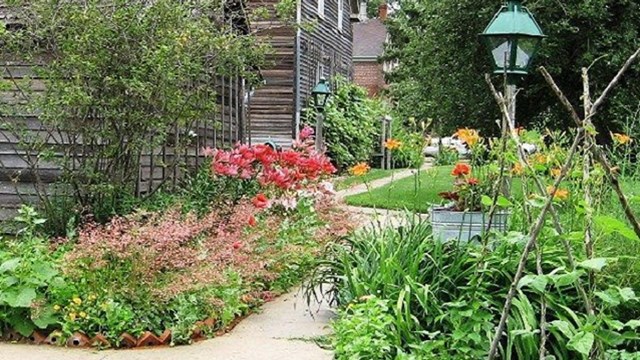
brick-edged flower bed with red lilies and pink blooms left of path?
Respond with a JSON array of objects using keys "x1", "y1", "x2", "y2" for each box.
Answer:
[{"x1": 0, "y1": 130, "x2": 351, "y2": 347}]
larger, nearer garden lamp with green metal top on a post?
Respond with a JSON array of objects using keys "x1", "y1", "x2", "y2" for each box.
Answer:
[{"x1": 480, "y1": 0, "x2": 545, "y2": 131}]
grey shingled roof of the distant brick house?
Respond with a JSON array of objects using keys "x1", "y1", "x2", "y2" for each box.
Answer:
[{"x1": 353, "y1": 19, "x2": 387, "y2": 59}]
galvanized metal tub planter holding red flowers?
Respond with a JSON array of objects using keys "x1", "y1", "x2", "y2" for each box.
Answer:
[{"x1": 430, "y1": 207, "x2": 509, "y2": 243}]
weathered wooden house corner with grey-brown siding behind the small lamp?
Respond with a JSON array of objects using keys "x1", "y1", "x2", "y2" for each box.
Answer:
[{"x1": 247, "y1": 0, "x2": 353, "y2": 146}]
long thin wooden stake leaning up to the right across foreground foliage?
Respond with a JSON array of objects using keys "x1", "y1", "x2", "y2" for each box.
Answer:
[{"x1": 487, "y1": 128, "x2": 584, "y2": 360}]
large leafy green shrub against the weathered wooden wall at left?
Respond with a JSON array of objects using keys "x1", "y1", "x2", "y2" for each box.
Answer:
[{"x1": 2, "y1": 0, "x2": 267, "y2": 222}]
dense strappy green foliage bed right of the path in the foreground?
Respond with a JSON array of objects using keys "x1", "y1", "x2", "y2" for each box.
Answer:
[{"x1": 307, "y1": 216, "x2": 640, "y2": 360}]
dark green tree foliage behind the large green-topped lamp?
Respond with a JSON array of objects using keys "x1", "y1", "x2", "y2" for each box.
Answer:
[{"x1": 386, "y1": 0, "x2": 640, "y2": 134}]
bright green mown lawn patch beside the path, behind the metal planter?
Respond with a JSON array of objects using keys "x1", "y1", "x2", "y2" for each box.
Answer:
[{"x1": 346, "y1": 166, "x2": 521, "y2": 212}]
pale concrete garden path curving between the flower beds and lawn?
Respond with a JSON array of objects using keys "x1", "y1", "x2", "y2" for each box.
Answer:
[{"x1": 0, "y1": 163, "x2": 431, "y2": 360}]
